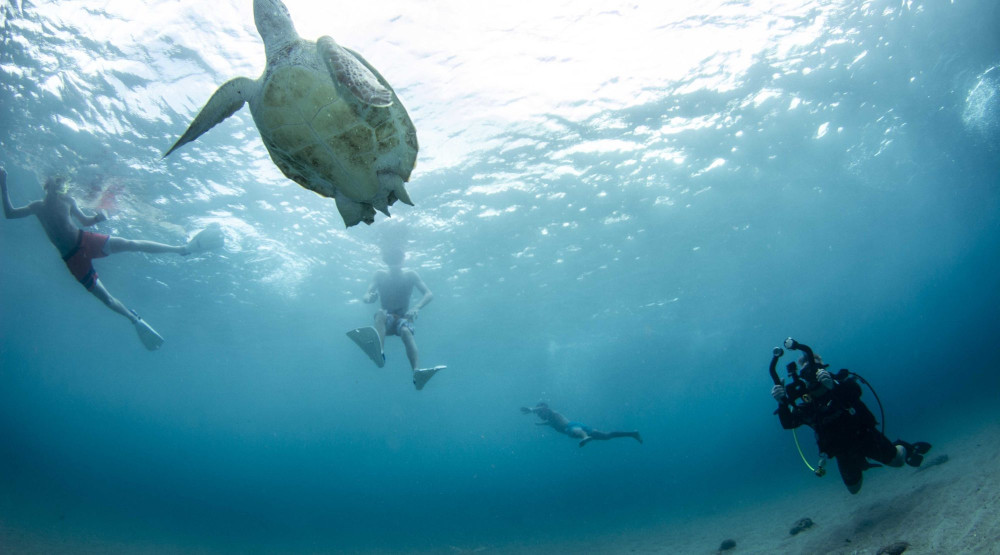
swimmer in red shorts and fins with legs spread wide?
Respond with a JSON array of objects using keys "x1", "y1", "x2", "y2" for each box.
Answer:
[{"x1": 0, "y1": 168, "x2": 223, "y2": 351}]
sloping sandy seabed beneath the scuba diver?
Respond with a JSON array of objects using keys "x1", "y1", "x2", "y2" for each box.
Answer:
[{"x1": 516, "y1": 412, "x2": 1000, "y2": 555}]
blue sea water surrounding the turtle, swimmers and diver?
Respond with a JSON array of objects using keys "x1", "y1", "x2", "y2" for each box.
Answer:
[{"x1": 0, "y1": 0, "x2": 1000, "y2": 552}]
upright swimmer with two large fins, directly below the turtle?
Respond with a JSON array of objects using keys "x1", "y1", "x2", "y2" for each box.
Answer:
[{"x1": 347, "y1": 246, "x2": 446, "y2": 390}]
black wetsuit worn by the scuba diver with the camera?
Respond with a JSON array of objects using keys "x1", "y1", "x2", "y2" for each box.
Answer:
[{"x1": 777, "y1": 378, "x2": 896, "y2": 488}]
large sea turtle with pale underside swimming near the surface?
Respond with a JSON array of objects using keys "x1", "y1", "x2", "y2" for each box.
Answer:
[{"x1": 163, "y1": 0, "x2": 418, "y2": 227}]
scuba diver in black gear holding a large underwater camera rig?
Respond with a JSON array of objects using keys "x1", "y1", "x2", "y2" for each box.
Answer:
[{"x1": 770, "y1": 337, "x2": 931, "y2": 494}]
